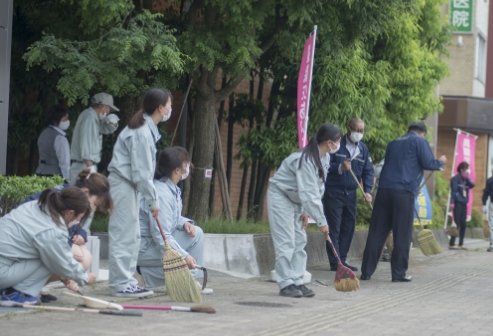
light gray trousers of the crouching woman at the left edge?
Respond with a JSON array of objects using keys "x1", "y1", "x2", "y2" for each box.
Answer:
[{"x1": 0, "y1": 257, "x2": 53, "y2": 296}]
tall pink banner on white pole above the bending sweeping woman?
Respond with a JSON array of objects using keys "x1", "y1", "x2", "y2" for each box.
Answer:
[{"x1": 297, "y1": 26, "x2": 317, "y2": 148}]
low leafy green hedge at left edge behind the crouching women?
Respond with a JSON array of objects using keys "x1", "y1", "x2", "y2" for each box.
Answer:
[{"x1": 0, "y1": 175, "x2": 64, "y2": 216}]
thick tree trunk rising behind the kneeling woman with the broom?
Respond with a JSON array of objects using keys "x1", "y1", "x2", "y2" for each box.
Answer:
[{"x1": 188, "y1": 91, "x2": 217, "y2": 221}]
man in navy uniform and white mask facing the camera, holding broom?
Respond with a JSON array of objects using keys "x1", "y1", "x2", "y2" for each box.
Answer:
[{"x1": 324, "y1": 118, "x2": 373, "y2": 271}]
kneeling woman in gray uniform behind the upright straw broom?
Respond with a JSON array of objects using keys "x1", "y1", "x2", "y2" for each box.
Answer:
[{"x1": 137, "y1": 146, "x2": 212, "y2": 294}]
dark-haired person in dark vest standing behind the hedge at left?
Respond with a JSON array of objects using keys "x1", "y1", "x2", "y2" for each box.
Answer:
[{"x1": 36, "y1": 105, "x2": 70, "y2": 179}]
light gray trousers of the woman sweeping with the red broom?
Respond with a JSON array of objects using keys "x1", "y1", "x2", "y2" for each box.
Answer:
[{"x1": 267, "y1": 184, "x2": 307, "y2": 289}]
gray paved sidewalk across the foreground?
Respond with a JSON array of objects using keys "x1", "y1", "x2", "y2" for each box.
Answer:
[{"x1": 0, "y1": 241, "x2": 493, "y2": 336}]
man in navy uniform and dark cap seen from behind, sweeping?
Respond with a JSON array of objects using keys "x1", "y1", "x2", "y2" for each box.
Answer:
[{"x1": 361, "y1": 122, "x2": 447, "y2": 282}]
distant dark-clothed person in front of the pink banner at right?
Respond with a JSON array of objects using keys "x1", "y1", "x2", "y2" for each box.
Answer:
[{"x1": 449, "y1": 161, "x2": 474, "y2": 250}]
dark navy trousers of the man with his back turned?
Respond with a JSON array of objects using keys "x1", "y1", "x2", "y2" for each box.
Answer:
[{"x1": 361, "y1": 189, "x2": 414, "y2": 279}]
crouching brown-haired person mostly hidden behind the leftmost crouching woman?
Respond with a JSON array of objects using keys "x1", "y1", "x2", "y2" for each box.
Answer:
[{"x1": 19, "y1": 169, "x2": 113, "y2": 302}]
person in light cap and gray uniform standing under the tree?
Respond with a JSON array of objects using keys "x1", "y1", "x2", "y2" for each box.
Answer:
[{"x1": 70, "y1": 92, "x2": 120, "y2": 184}]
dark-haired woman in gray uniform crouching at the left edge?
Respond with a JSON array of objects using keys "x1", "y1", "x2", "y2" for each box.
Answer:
[{"x1": 0, "y1": 187, "x2": 96, "y2": 306}]
